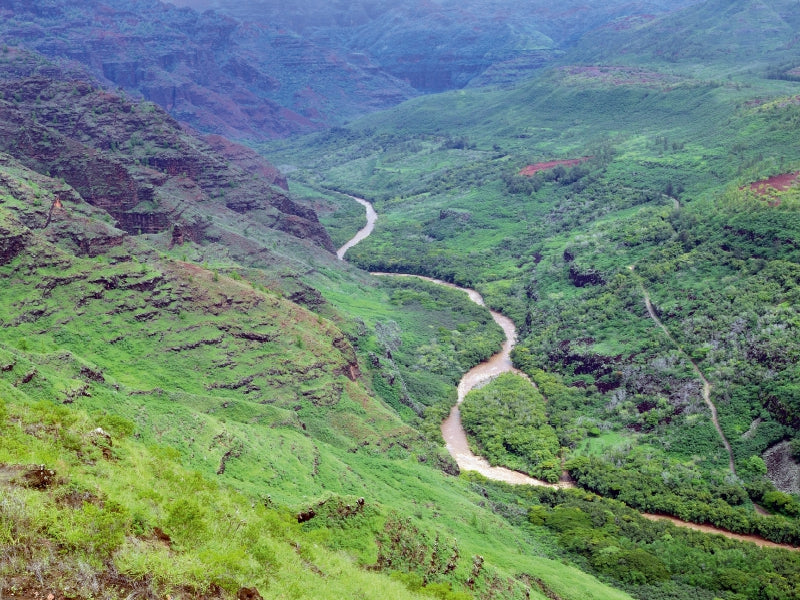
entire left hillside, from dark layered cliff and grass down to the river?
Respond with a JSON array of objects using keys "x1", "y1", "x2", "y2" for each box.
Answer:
[{"x1": 0, "y1": 50, "x2": 644, "y2": 600}]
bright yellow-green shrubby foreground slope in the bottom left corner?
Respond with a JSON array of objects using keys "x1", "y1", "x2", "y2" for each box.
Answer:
[{"x1": 0, "y1": 392, "x2": 438, "y2": 598}]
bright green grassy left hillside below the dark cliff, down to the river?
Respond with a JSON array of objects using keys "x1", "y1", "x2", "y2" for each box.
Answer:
[{"x1": 0, "y1": 156, "x2": 624, "y2": 598}]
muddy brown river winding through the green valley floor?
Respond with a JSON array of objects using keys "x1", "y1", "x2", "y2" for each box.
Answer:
[{"x1": 336, "y1": 196, "x2": 800, "y2": 550}]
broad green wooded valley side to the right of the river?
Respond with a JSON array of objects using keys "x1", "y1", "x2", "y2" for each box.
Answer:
[{"x1": 264, "y1": 41, "x2": 800, "y2": 592}]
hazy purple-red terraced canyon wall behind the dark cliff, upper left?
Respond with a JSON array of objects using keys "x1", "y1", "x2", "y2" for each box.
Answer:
[{"x1": 0, "y1": 0, "x2": 414, "y2": 139}]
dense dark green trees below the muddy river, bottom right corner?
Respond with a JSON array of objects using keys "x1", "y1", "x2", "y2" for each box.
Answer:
[{"x1": 466, "y1": 477, "x2": 800, "y2": 600}]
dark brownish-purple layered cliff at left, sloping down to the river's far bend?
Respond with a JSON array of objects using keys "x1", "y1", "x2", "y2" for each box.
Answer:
[{"x1": 0, "y1": 49, "x2": 334, "y2": 251}]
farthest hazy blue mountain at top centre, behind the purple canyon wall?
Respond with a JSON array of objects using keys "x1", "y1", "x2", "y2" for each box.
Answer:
[{"x1": 170, "y1": 0, "x2": 693, "y2": 93}]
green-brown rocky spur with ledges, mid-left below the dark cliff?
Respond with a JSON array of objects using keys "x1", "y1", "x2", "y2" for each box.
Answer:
[{"x1": 0, "y1": 153, "x2": 366, "y2": 429}]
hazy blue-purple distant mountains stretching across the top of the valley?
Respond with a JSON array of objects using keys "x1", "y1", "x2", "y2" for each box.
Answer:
[{"x1": 0, "y1": 0, "x2": 708, "y2": 141}]
